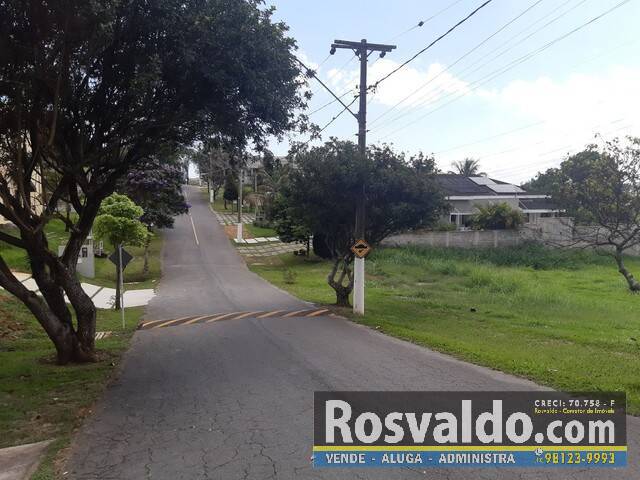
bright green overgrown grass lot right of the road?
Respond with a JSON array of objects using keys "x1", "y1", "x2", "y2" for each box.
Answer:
[{"x1": 252, "y1": 245, "x2": 640, "y2": 414}]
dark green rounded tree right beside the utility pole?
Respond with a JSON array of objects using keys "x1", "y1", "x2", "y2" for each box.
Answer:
[{"x1": 277, "y1": 139, "x2": 446, "y2": 306}]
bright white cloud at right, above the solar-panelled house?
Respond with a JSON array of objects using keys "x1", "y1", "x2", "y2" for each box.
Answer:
[{"x1": 442, "y1": 67, "x2": 640, "y2": 181}]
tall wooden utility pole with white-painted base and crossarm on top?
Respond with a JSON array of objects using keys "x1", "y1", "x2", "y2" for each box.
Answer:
[{"x1": 330, "y1": 39, "x2": 396, "y2": 315}]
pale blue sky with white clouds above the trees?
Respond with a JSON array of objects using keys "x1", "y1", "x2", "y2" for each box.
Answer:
[{"x1": 267, "y1": 0, "x2": 640, "y2": 183}]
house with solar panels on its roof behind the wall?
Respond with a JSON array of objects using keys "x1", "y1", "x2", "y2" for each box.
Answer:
[{"x1": 436, "y1": 173, "x2": 560, "y2": 229}]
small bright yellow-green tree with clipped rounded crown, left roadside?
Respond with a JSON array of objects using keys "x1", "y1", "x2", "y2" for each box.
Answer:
[{"x1": 93, "y1": 193, "x2": 151, "y2": 310}]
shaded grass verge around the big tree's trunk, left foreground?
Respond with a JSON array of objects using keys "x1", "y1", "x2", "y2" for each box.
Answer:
[{"x1": 0, "y1": 293, "x2": 143, "y2": 448}]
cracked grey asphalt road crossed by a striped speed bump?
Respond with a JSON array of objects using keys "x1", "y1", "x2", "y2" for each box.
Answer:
[{"x1": 65, "y1": 187, "x2": 640, "y2": 480}]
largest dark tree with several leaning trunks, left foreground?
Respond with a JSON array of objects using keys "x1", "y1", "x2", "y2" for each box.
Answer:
[{"x1": 0, "y1": 0, "x2": 306, "y2": 363}]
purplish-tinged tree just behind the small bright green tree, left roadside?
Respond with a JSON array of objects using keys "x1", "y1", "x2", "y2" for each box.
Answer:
[{"x1": 120, "y1": 148, "x2": 188, "y2": 274}]
